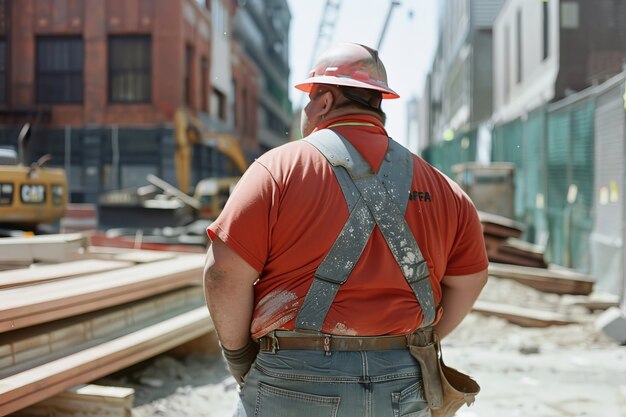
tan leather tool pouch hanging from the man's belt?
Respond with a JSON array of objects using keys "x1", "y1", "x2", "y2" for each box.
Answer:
[{"x1": 409, "y1": 335, "x2": 480, "y2": 417}]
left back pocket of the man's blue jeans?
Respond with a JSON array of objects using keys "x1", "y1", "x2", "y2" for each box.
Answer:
[{"x1": 254, "y1": 382, "x2": 340, "y2": 417}]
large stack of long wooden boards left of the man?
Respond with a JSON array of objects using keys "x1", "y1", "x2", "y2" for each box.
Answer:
[{"x1": 0, "y1": 237, "x2": 213, "y2": 416}]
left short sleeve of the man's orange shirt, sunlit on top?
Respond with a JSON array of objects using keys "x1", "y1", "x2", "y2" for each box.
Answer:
[{"x1": 207, "y1": 162, "x2": 280, "y2": 273}]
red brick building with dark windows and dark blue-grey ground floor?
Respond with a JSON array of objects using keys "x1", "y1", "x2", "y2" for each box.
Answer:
[{"x1": 0, "y1": 0, "x2": 266, "y2": 202}]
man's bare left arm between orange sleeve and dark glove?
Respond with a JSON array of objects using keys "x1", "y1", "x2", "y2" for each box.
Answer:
[{"x1": 204, "y1": 238, "x2": 259, "y2": 350}]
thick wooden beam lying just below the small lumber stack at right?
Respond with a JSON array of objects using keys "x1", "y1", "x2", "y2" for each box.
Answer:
[{"x1": 489, "y1": 262, "x2": 594, "y2": 295}]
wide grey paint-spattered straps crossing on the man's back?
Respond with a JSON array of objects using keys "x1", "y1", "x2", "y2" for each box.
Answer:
[{"x1": 295, "y1": 129, "x2": 436, "y2": 332}]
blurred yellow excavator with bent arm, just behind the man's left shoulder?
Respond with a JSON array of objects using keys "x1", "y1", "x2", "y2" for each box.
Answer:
[{"x1": 174, "y1": 109, "x2": 248, "y2": 219}]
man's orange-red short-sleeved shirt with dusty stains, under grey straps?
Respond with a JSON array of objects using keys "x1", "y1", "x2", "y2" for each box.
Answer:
[{"x1": 208, "y1": 115, "x2": 488, "y2": 337}]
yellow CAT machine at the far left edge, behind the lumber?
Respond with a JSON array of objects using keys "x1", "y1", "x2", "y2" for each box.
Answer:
[{"x1": 0, "y1": 123, "x2": 68, "y2": 232}]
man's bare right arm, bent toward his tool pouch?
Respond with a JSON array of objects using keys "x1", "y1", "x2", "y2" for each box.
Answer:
[{"x1": 435, "y1": 269, "x2": 487, "y2": 339}]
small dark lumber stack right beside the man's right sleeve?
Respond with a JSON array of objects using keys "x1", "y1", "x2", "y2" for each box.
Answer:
[{"x1": 478, "y1": 212, "x2": 547, "y2": 268}]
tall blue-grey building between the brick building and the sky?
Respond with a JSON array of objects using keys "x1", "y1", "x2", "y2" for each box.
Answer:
[{"x1": 234, "y1": 0, "x2": 293, "y2": 150}]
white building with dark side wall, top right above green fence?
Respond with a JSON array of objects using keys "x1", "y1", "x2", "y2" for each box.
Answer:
[{"x1": 493, "y1": 0, "x2": 626, "y2": 123}]
